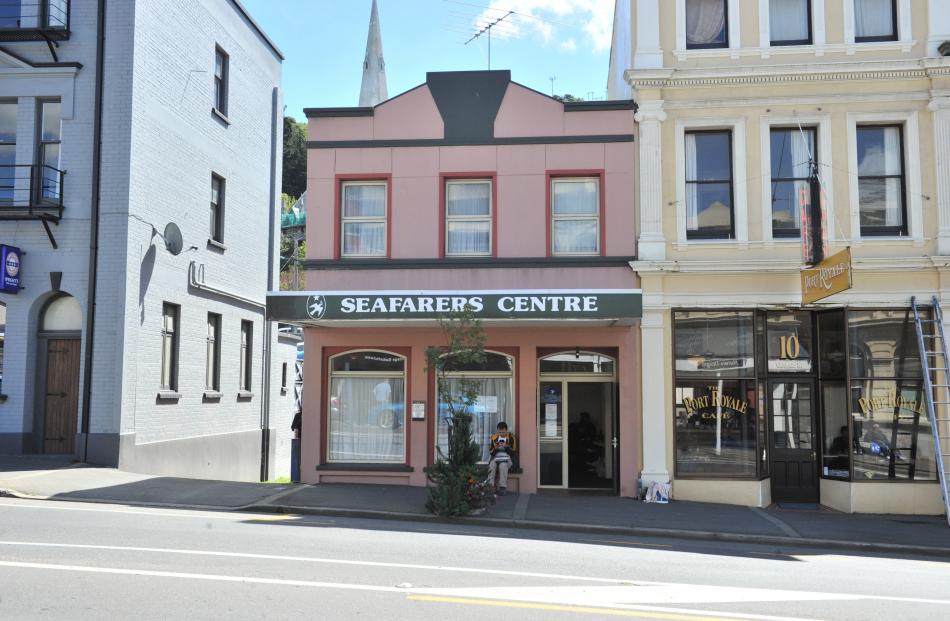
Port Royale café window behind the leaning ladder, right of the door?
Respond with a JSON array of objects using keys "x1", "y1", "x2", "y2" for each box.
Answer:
[{"x1": 848, "y1": 310, "x2": 936, "y2": 481}]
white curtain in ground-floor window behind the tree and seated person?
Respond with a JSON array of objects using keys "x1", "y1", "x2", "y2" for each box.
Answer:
[{"x1": 436, "y1": 377, "x2": 515, "y2": 461}]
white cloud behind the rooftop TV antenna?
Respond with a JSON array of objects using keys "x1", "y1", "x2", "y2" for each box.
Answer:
[{"x1": 475, "y1": 0, "x2": 614, "y2": 52}]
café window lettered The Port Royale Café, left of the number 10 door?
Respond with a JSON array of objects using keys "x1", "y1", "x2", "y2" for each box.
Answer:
[{"x1": 673, "y1": 311, "x2": 766, "y2": 478}]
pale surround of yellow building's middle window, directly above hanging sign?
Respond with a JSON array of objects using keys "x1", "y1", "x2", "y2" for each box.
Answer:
[{"x1": 759, "y1": 114, "x2": 836, "y2": 245}]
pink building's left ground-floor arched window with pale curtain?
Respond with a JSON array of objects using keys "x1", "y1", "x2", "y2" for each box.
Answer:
[{"x1": 327, "y1": 351, "x2": 406, "y2": 463}]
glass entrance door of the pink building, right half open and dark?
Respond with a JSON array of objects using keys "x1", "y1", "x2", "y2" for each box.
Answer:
[{"x1": 538, "y1": 378, "x2": 619, "y2": 491}]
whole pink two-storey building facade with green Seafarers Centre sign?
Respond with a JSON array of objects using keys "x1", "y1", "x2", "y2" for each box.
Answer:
[{"x1": 268, "y1": 71, "x2": 642, "y2": 495}]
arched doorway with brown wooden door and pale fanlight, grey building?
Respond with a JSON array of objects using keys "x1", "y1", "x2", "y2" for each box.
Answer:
[{"x1": 35, "y1": 294, "x2": 82, "y2": 454}]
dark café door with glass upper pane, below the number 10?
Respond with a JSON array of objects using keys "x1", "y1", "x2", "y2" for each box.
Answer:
[{"x1": 769, "y1": 379, "x2": 818, "y2": 502}]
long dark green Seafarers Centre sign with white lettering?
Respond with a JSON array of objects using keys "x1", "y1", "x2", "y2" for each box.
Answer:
[{"x1": 267, "y1": 289, "x2": 643, "y2": 323}]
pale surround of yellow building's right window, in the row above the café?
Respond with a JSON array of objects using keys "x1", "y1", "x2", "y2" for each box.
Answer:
[{"x1": 848, "y1": 110, "x2": 924, "y2": 246}]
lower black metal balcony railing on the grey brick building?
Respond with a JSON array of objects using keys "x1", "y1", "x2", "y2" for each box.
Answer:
[{"x1": 0, "y1": 164, "x2": 66, "y2": 222}]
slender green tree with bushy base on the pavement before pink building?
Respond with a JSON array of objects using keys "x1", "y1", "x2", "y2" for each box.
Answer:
[{"x1": 426, "y1": 306, "x2": 495, "y2": 517}]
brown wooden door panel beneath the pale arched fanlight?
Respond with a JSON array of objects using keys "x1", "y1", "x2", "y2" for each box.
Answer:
[{"x1": 43, "y1": 339, "x2": 79, "y2": 454}]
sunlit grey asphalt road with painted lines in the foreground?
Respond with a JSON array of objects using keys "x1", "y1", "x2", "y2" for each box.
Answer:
[{"x1": 0, "y1": 498, "x2": 950, "y2": 621}]
